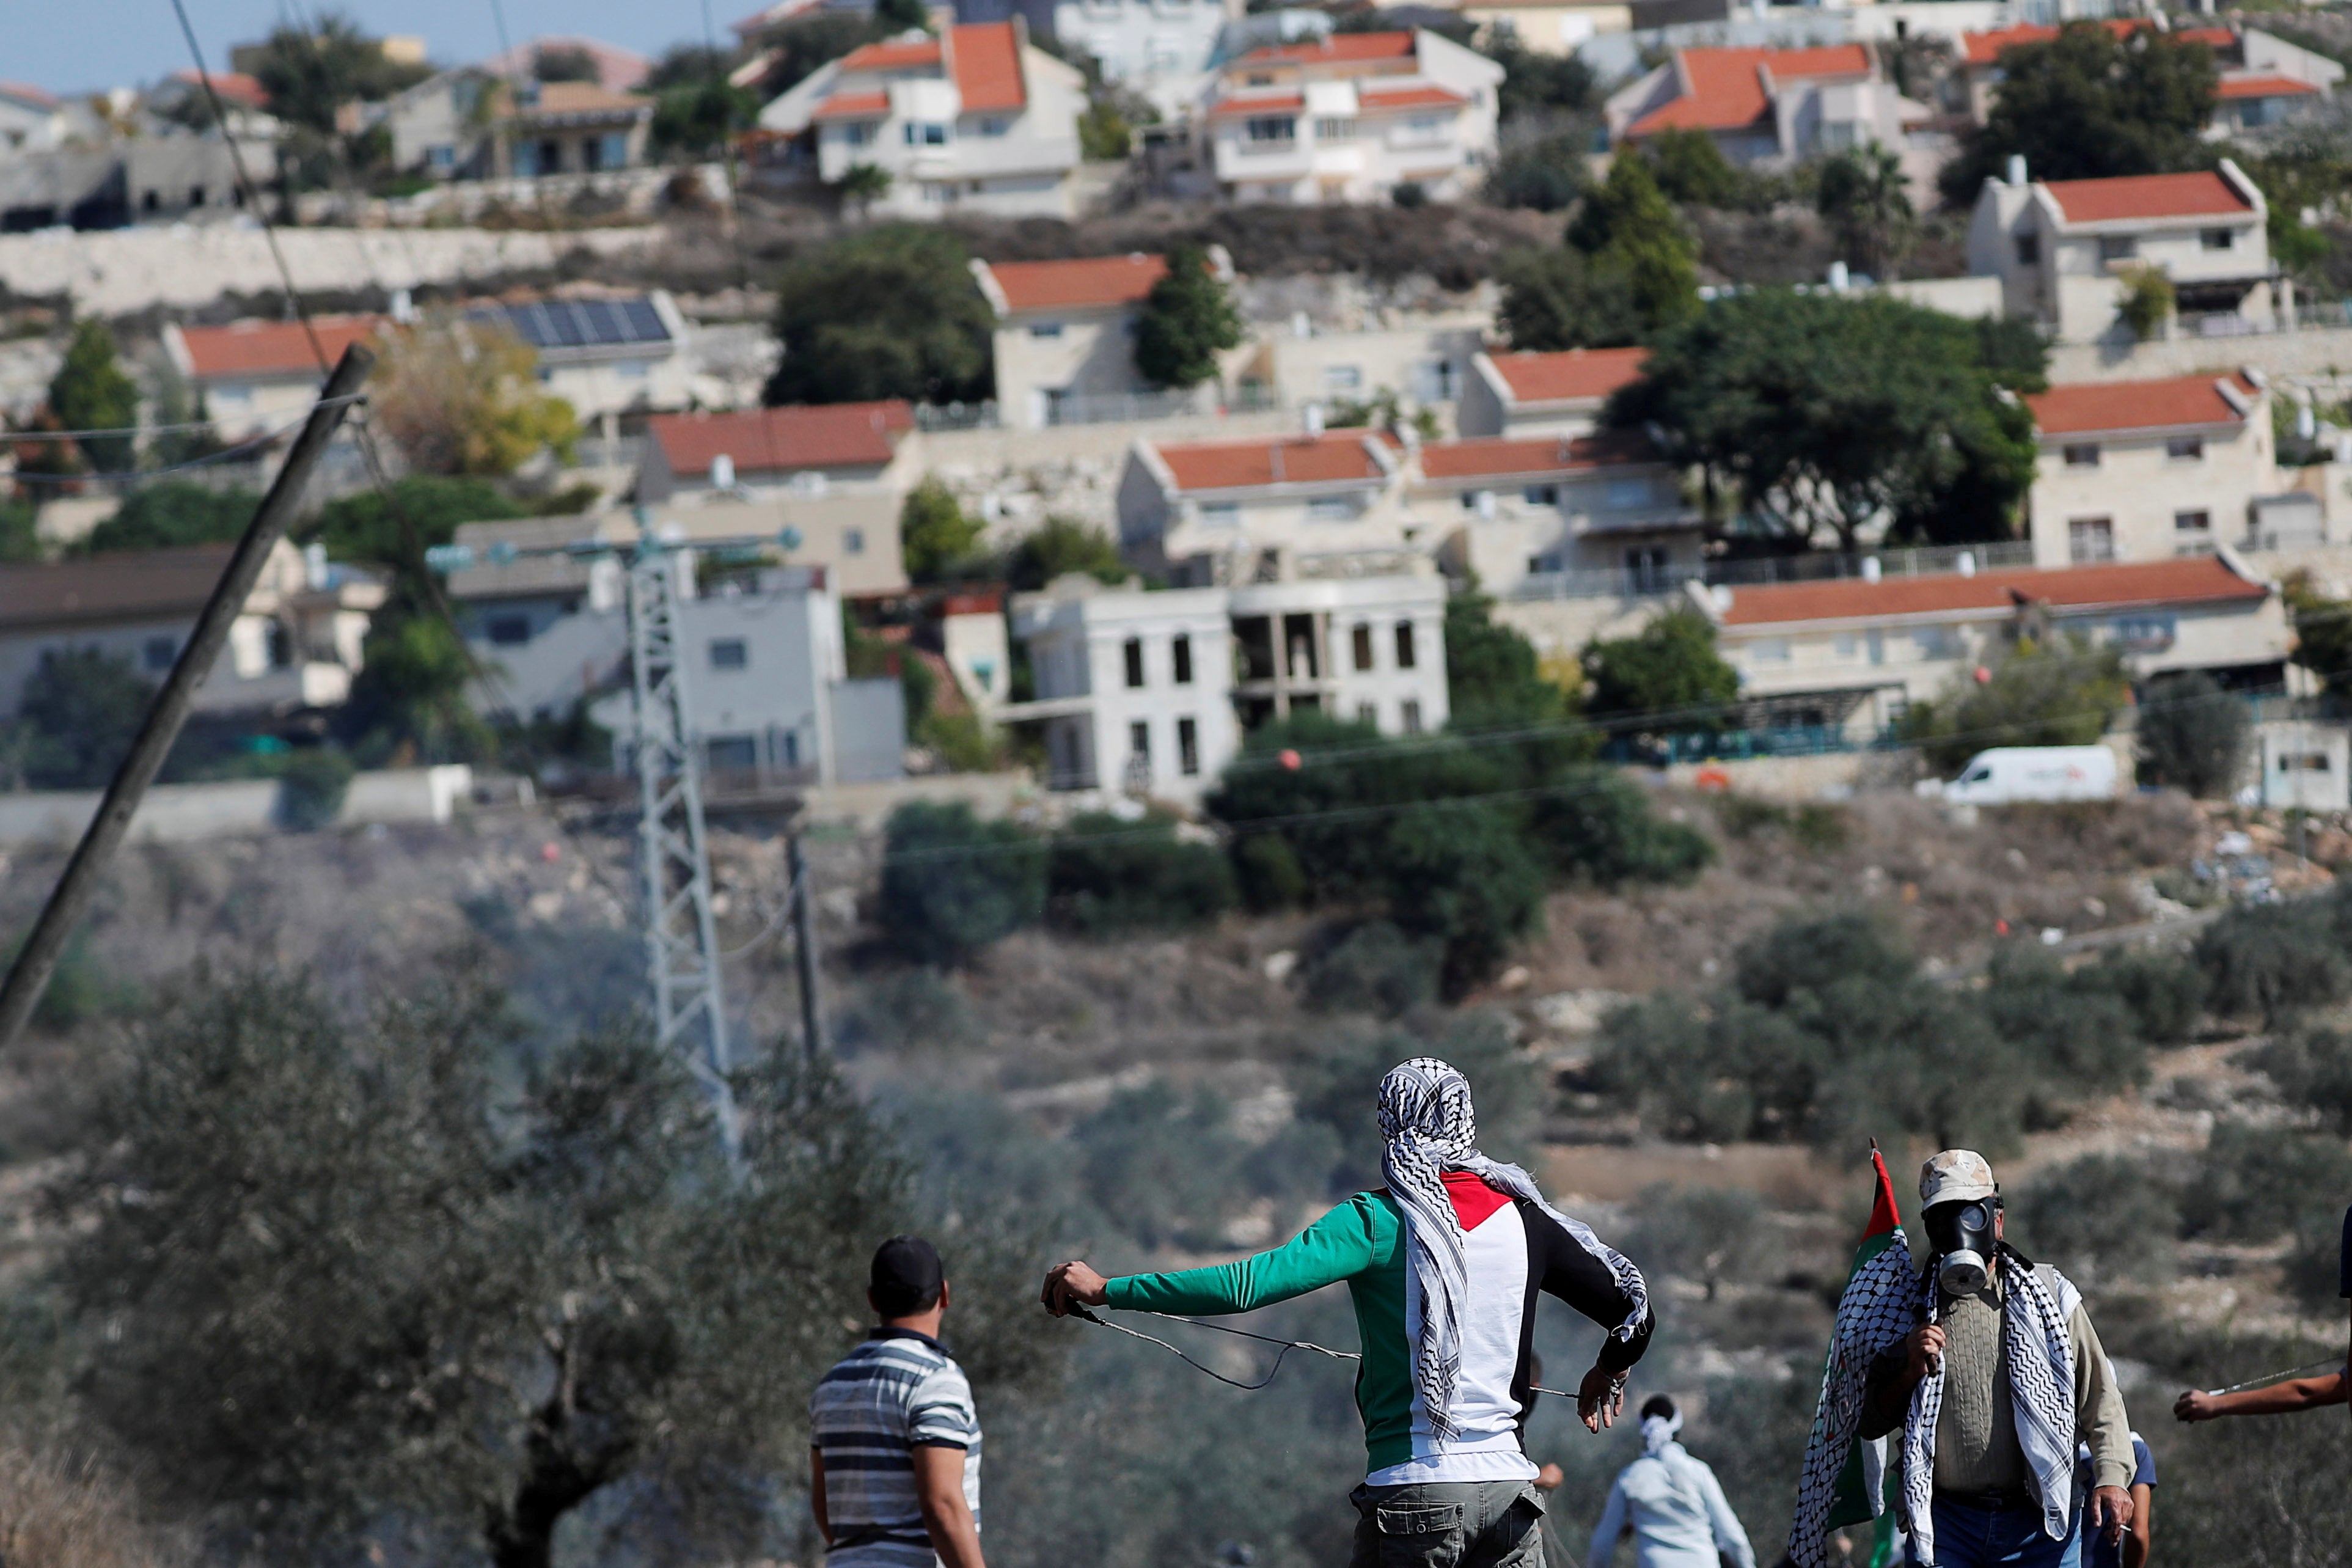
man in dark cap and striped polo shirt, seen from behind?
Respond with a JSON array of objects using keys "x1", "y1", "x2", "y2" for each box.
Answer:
[{"x1": 809, "y1": 1237, "x2": 983, "y2": 1568}]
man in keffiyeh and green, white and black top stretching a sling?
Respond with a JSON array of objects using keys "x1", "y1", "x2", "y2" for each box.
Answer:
[{"x1": 1044, "y1": 1055, "x2": 1651, "y2": 1568}]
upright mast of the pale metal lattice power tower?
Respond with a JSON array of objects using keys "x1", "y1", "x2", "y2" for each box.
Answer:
[{"x1": 628, "y1": 538, "x2": 741, "y2": 1163}]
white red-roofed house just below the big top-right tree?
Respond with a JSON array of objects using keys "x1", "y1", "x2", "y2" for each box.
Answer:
[{"x1": 1969, "y1": 158, "x2": 2272, "y2": 343}]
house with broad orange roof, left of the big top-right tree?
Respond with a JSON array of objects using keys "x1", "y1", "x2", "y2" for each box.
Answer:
[{"x1": 1602, "y1": 42, "x2": 1945, "y2": 178}]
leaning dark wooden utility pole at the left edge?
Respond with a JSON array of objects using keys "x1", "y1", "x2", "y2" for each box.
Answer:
[{"x1": 0, "y1": 343, "x2": 376, "y2": 1051}]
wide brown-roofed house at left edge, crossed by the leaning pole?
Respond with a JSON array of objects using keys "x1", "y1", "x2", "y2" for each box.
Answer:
[{"x1": 0, "y1": 538, "x2": 383, "y2": 724}]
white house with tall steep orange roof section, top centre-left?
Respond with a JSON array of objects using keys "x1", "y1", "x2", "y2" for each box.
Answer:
[{"x1": 755, "y1": 16, "x2": 1086, "y2": 219}]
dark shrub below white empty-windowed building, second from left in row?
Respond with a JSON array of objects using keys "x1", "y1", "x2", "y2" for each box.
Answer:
[{"x1": 1047, "y1": 813, "x2": 1235, "y2": 936}]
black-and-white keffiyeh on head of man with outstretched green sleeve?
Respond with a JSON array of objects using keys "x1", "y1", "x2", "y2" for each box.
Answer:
[{"x1": 1380, "y1": 1055, "x2": 1649, "y2": 1441}]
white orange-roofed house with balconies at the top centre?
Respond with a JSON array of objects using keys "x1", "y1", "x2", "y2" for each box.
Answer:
[{"x1": 1195, "y1": 31, "x2": 1503, "y2": 207}]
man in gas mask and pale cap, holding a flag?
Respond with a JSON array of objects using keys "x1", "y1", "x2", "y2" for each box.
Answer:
[{"x1": 1861, "y1": 1149, "x2": 2133, "y2": 1568}]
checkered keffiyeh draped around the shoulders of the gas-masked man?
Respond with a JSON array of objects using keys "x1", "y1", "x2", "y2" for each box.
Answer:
[{"x1": 1787, "y1": 1232, "x2": 2081, "y2": 1568}]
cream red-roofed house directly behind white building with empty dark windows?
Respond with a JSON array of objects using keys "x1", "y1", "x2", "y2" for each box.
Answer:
[{"x1": 1117, "y1": 428, "x2": 1430, "y2": 585}]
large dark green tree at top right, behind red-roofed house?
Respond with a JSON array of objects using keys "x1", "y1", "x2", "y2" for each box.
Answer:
[{"x1": 1940, "y1": 21, "x2": 2220, "y2": 207}]
